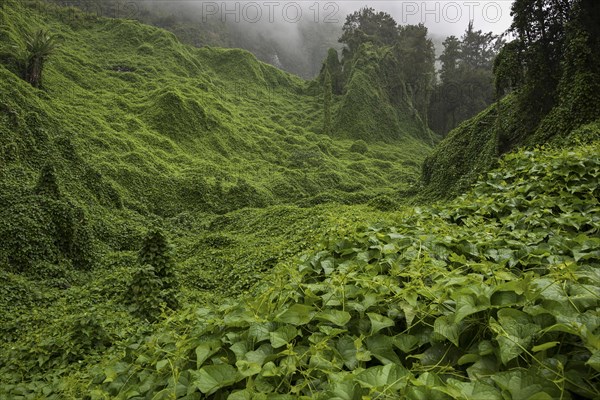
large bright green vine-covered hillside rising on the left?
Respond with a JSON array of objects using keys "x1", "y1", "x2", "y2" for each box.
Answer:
[{"x1": 0, "y1": 1, "x2": 430, "y2": 269}]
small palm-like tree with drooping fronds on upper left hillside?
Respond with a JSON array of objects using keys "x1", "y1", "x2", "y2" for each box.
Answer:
[{"x1": 25, "y1": 29, "x2": 56, "y2": 88}]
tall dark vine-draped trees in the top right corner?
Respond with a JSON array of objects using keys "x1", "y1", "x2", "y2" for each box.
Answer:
[{"x1": 494, "y1": 0, "x2": 600, "y2": 143}]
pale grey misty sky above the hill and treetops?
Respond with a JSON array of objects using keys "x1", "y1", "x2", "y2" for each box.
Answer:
[{"x1": 132, "y1": 0, "x2": 512, "y2": 78}]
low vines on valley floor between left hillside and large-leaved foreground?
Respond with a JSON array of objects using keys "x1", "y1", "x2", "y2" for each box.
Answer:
[{"x1": 0, "y1": 205, "x2": 390, "y2": 398}]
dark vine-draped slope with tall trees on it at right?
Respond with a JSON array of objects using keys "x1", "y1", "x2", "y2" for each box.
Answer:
[{"x1": 423, "y1": 0, "x2": 600, "y2": 197}]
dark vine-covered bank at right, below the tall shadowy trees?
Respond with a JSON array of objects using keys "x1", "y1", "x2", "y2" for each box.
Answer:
[{"x1": 421, "y1": 95, "x2": 600, "y2": 199}]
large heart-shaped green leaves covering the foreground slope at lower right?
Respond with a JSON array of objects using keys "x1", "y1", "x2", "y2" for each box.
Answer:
[{"x1": 29, "y1": 143, "x2": 600, "y2": 399}]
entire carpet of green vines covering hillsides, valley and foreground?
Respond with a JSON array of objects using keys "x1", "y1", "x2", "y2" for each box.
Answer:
[{"x1": 0, "y1": 0, "x2": 600, "y2": 400}]
